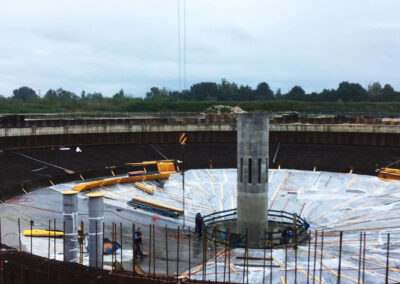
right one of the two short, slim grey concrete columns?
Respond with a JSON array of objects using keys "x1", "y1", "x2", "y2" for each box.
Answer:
[{"x1": 86, "y1": 193, "x2": 104, "y2": 268}]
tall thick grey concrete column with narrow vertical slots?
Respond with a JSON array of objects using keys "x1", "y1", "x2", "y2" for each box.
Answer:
[{"x1": 237, "y1": 113, "x2": 269, "y2": 247}]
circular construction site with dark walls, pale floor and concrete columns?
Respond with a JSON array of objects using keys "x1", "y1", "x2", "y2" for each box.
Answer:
[{"x1": 0, "y1": 113, "x2": 400, "y2": 283}]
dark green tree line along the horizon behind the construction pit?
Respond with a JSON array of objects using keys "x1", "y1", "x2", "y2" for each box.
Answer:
[{"x1": 0, "y1": 79, "x2": 400, "y2": 113}]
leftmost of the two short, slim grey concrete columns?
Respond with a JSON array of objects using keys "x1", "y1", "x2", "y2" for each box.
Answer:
[{"x1": 62, "y1": 190, "x2": 78, "y2": 262}]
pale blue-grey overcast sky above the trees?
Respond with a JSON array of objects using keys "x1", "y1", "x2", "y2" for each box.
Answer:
[{"x1": 0, "y1": 0, "x2": 400, "y2": 96}]
